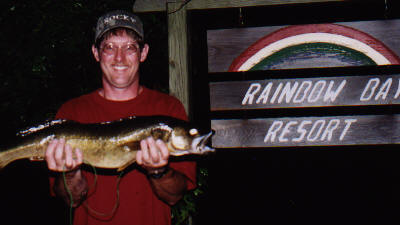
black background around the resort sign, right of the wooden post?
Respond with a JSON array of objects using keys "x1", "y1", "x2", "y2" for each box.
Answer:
[{"x1": 189, "y1": 1, "x2": 400, "y2": 225}]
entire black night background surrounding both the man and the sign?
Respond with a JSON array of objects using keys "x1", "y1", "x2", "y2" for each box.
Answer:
[{"x1": 0, "y1": 0, "x2": 400, "y2": 225}]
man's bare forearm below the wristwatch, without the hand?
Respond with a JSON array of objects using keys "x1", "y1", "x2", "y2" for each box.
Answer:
[{"x1": 149, "y1": 168, "x2": 187, "y2": 205}]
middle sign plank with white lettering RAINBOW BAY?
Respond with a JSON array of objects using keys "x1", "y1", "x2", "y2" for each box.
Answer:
[{"x1": 209, "y1": 74, "x2": 400, "y2": 111}]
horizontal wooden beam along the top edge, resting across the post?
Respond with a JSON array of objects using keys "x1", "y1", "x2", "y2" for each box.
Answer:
[{"x1": 133, "y1": 0, "x2": 351, "y2": 12}]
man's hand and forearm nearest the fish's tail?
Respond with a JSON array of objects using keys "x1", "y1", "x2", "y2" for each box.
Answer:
[{"x1": 46, "y1": 139, "x2": 88, "y2": 207}]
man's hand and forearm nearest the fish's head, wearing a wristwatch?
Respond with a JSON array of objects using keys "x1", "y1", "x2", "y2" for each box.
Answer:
[{"x1": 136, "y1": 138, "x2": 188, "y2": 205}]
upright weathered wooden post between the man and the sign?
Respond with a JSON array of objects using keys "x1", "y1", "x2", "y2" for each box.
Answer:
[{"x1": 168, "y1": 3, "x2": 190, "y2": 114}]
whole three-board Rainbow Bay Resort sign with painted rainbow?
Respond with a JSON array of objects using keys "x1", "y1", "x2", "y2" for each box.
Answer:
[{"x1": 207, "y1": 19, "x2": 400, "y2": 148}]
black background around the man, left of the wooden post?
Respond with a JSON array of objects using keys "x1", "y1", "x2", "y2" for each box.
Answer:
[{"x1": 0, "y1": 0, "x2": 168, "y2": 225}]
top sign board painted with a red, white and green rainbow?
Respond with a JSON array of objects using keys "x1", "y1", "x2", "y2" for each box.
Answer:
[{"x1": 207, "y1": 19, "x2": 400, "y2": 72}]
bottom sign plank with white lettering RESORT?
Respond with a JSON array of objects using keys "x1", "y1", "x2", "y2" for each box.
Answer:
[{"x1": 211, "y1": 114, "x2": 400, "y2": 148}]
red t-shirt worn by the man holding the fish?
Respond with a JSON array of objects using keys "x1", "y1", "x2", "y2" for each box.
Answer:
[{"x1": 52, "y1": 88, "x2": 196, "y2": 225}]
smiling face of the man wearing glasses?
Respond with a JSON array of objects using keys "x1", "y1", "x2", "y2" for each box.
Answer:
[{"x1": 92, "y1": 32, "x2": 148, "y2": 89}]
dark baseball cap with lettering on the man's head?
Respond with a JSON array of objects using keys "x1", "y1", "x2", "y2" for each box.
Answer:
[{"x1": 94, "y1": 10, "x2": 144, "y2": 43}]
